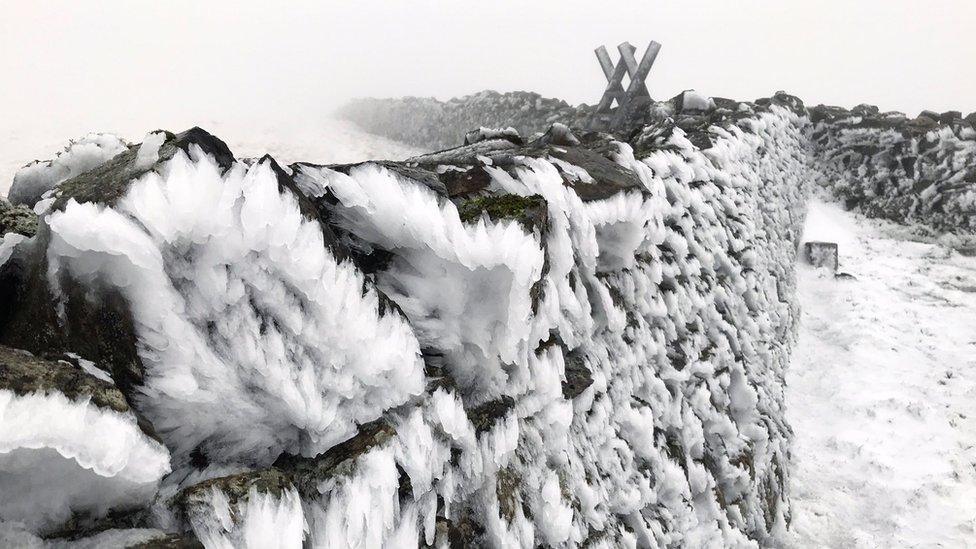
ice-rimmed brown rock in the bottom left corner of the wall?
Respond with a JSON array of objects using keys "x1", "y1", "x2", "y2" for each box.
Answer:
[{"x1": 0, "y1": 346, "x2": 170, "y2": 533}]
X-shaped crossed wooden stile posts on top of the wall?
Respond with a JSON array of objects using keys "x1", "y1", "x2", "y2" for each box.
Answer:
[{"x1": 594, "y1": 41, "x2": 661, "y2": 130}]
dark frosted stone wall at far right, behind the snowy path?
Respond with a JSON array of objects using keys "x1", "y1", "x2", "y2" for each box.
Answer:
[{"x1": 810, "y1": 106, "x2": 976, "y2": 235}]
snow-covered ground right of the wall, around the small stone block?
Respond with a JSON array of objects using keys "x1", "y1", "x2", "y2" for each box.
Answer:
[{"x1": 786, "y1": 202, "x2": 976, "y2": 548}]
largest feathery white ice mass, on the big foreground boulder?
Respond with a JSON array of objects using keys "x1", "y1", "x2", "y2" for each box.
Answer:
[{"x1": 46, "y1": 149, "x2": 423, "y2": 465}]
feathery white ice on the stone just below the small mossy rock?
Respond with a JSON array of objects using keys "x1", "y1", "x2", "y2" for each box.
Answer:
[{"x1": 298, "y1": 164, "x2": 544, "y2": 396}]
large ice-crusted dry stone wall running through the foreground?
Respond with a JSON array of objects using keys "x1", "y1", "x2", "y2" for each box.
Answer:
[{"x1": 0, "y1": 95, "x2": 813, "y2": 547}]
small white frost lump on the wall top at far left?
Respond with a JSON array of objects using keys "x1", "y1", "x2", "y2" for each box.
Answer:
[{"x1": 7, "y1": 133, "x2": 127, "y2": 207}]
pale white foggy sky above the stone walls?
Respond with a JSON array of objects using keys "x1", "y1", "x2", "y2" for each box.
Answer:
[{"x1": 0, "y1": 0, "x2": 976, "y2": 188}]
